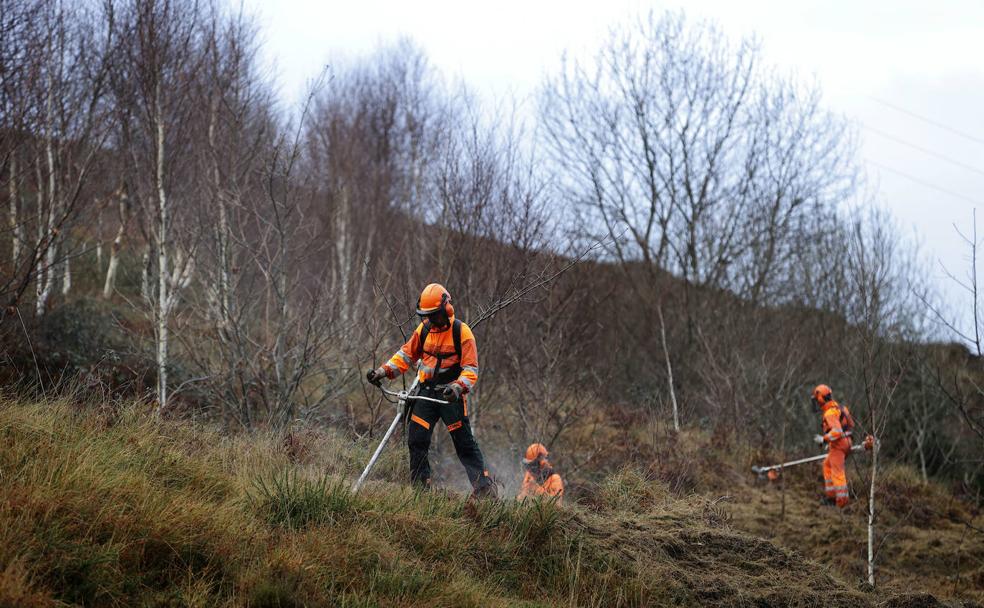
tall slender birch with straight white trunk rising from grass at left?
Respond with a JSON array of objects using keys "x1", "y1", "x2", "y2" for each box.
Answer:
[{"x1": 107, "y1": 0, "x2": 204, "y2": 412}]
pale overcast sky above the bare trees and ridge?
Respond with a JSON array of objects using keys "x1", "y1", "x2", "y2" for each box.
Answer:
[{"x1": 245, "y1": 0, "x2": 984, "y2": 324}]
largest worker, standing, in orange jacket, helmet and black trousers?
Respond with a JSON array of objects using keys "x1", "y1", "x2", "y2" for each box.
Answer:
[{"x1": 366, "y1": 283, "x2": 496, "y2": 498}]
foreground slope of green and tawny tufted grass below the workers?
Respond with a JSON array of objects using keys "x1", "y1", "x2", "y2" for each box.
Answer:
[{"x1": 0, "y1": 399, "x2": 976, "y2": 607}]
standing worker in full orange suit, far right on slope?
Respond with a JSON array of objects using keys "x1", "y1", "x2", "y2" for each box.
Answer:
[{"x1": 813, "y1": 384, "x2": 854, "y2": 508}]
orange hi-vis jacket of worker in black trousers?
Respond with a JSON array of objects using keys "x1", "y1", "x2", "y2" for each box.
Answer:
[{"x1": 383, "y1": 317, "x2": 478, "y2": 393}]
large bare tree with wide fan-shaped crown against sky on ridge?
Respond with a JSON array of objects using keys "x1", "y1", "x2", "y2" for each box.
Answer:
[{"x1": 541, "y1": 14, "x2": 853, "y2": 309}]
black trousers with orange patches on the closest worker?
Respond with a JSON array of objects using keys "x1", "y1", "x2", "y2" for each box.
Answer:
[{"x1": 407, "y1": 386, "x2": 492, "y2": 489}]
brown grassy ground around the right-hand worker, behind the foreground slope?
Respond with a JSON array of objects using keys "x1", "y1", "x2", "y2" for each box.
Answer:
[{"x1": 650, "y1": 431, "x2": 984, "y2": 605}]
